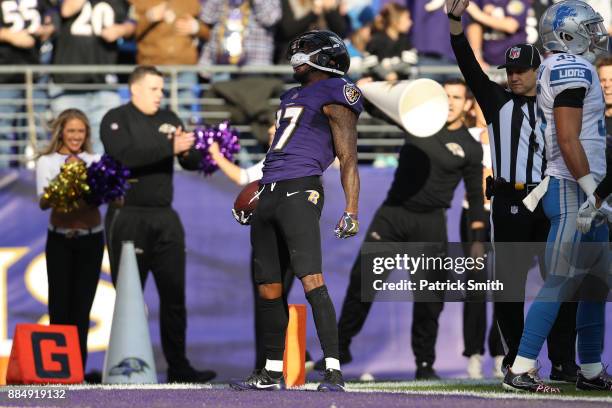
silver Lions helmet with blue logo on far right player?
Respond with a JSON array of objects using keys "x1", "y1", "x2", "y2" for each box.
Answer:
[{"x1": 540, "y1": 0, "x2": 608, "y2": 62}]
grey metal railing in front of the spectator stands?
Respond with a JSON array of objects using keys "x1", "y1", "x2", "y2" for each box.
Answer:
[{"x1": 0, "y1": 65, "x2": 478, "y2": 164}]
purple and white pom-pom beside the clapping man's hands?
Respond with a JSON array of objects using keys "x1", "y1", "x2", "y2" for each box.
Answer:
[{"x1": 193, "y1": 122, "x2": 240, "y2": 176}]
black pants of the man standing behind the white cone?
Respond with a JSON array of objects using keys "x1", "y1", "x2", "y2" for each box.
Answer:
[{"x1": 105, "y1": 207, "x2": 189, "y2": 371}]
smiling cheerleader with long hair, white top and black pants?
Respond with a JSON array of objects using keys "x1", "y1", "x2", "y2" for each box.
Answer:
[{"x1": 36, "y1": 109, "x2": 104, "y2": 369}]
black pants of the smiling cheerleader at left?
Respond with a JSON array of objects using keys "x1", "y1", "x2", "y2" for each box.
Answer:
[{"x1": 45, "y1": 231, "x2": 104, "y2": 369}]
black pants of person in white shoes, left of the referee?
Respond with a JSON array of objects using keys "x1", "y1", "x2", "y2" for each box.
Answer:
[{"x1": 459, "y1": 209, "x2": 506, "y2": 357}]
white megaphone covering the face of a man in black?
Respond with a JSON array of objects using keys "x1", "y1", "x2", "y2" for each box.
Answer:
[{"x1": 359, "y1": 78, "x2": 448, "y2": 137}]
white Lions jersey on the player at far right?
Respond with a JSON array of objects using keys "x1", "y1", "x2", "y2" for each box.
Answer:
[{"x1": 537, "y1": 54, "x2": 606, "y2": 183}]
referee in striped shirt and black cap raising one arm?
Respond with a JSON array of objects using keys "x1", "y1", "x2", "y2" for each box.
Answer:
[{"x1": 446, "y1": 0, "x2": 578, "y2": 383}]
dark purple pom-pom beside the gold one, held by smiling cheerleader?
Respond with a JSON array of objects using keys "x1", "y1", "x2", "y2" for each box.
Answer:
[{"x1": 86, "y1": 154, "x2": 130, "y2": 205}]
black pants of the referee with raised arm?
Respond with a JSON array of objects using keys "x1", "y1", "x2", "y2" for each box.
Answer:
[{"x1": 491, "y1": 192, "x2": 577, "y2": 366}]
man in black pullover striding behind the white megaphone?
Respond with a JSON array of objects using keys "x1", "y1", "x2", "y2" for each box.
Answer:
[{"x1": 315, "y1": 80, "x2": 486, "y2": 379}]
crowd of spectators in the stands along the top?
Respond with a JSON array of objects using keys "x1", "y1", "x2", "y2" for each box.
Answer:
[{"x1": 0, "y1": 0, "x2": 612, "y2": 167}]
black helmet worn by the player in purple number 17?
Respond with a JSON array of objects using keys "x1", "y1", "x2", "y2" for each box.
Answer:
[{"x1": 287, "y1": 30, "x2": 351, "y2": 76}]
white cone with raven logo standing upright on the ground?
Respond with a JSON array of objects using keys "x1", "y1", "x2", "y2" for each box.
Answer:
[{"x1": 102, "y1": 241, "x2": 157, "y2": 384}]
